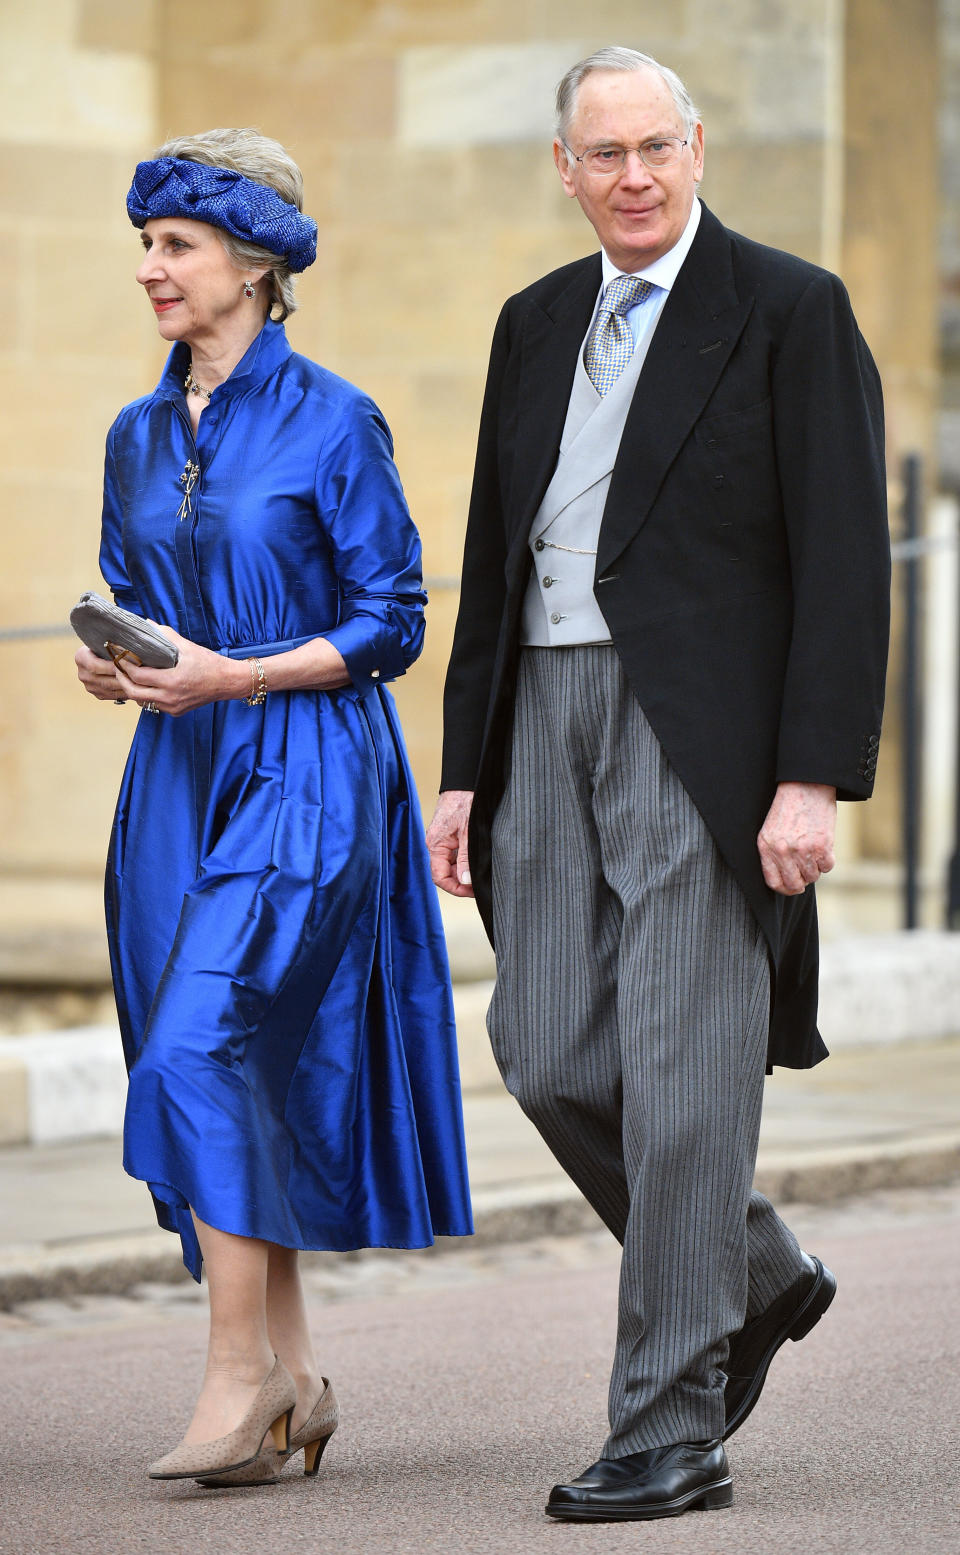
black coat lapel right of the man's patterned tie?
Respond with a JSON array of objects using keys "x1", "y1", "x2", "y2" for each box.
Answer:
[{"x1": 597, "y1": 207, "x2": 753, "y2": 577}]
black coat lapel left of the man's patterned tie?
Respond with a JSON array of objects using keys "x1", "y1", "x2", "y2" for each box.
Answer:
[{"x1": 507, "y1": 253, "x2": 602, "y2": 569}]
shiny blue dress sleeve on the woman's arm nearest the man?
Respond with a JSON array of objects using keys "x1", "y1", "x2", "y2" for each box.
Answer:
[{"x1": 316, "y1": 397, "x2": 426, "y2": 690}]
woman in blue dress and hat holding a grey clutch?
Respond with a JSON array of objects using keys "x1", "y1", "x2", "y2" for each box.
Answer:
[{"x1": 76, "y1": 131, "x2": 471, "y2": 1483}]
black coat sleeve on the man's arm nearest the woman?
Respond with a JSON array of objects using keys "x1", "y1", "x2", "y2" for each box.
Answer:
[{"x1": 440, "y1": 303, "x2": 512, "y2": 790}]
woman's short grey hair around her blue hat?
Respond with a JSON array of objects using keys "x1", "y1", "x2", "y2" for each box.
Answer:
[{"x1": 154, "y1": 129, "x2": 303, "y2": 323}]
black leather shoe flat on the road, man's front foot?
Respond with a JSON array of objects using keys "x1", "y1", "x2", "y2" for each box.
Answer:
[{"x1": 546, "y1": 1441, "x2": 733, "y2": 1522}]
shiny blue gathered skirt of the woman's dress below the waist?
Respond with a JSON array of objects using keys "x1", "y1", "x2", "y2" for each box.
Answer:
[{"x1": 106, "y1": 687, "x2": 473, "y2": 1278}]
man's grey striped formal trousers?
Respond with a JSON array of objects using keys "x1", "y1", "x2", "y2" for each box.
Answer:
[{"x1": 489, "y1": 644, "x2": 801, "y2": 1457}]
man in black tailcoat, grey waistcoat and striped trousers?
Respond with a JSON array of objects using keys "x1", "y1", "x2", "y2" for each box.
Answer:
[{"x1": 428, "y1": 48, "x2": 888, "y2": 1519}]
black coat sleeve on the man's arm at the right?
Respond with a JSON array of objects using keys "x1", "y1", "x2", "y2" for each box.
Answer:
[{"x1": 773, "y1": 272, "x2": 890, "y2": 799}]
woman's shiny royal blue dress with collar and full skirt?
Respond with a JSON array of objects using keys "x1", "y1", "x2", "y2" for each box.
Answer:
[{"x1": 101, "y1": 322, "x2": 471, "y2": 1278}]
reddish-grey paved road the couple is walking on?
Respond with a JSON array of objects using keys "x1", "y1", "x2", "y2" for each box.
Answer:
[{"x1": 0, "y1": 1186, "x2": 960, "y2": 1555}]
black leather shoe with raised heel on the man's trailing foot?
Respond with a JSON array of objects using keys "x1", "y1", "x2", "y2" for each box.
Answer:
[{"x1": 724, "y1": 1253, "x2": 837, "y2": 1440}]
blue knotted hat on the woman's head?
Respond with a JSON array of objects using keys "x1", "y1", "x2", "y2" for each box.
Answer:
[{"x1": 126, "y1": 157, "x2": 317, "y2": 272}]
